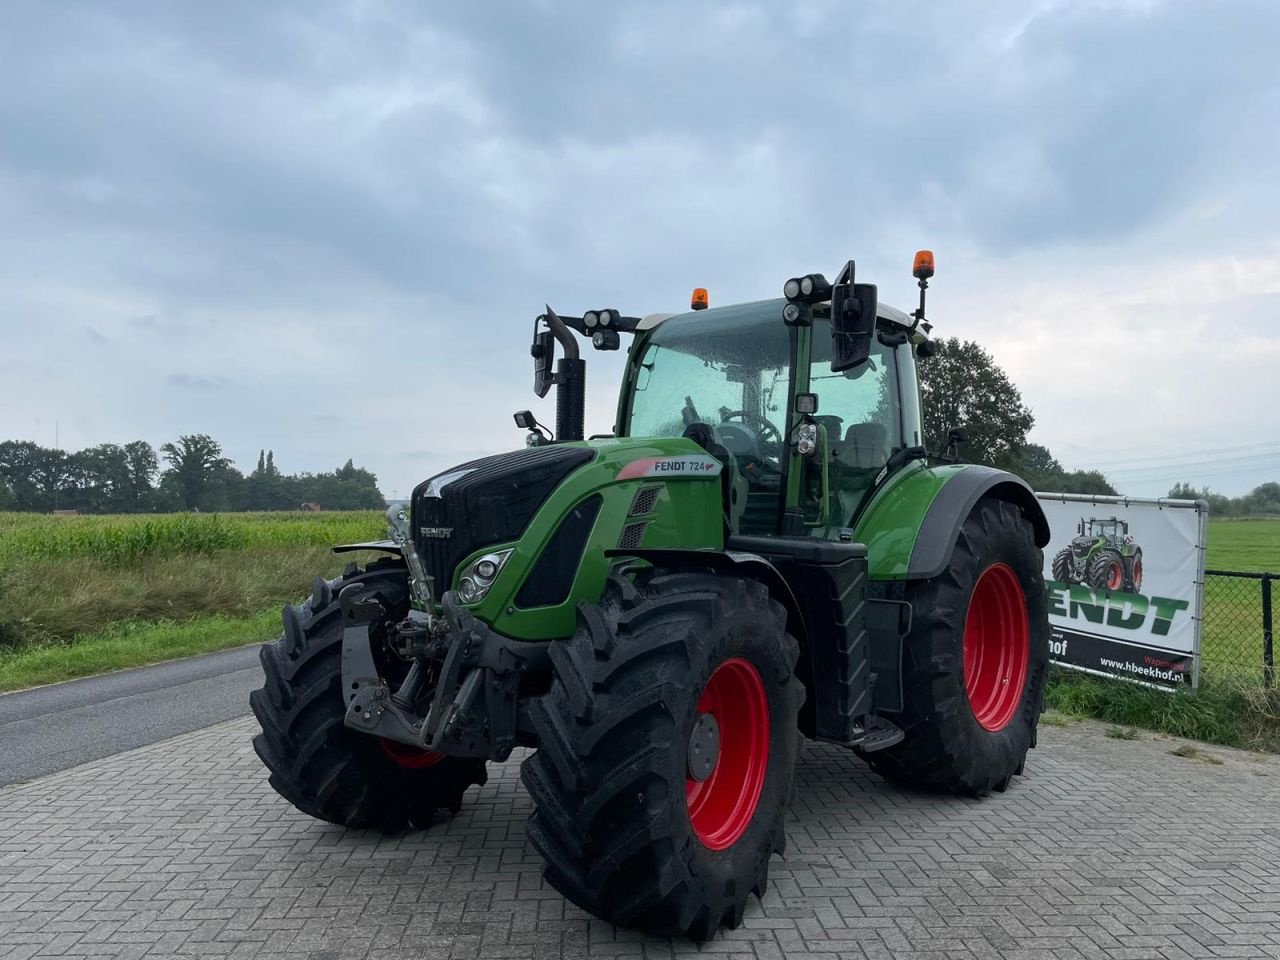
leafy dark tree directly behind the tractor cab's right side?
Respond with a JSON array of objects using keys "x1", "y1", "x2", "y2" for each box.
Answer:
[{"x1": 919, "y1": 337, "x2": 1047, "y2": 465}]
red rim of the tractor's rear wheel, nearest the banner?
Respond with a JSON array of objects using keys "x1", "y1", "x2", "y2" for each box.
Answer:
[{"x1": 964, "y1": 563, "x2": 1030, "y2": 732}]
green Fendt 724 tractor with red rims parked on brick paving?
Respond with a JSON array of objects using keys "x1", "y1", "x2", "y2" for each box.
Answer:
[{"x1": 251, "y1": 251, "x2": 1050, "y2": 940}]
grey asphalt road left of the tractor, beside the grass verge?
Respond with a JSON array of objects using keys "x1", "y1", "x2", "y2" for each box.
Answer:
[{"x1": 0, "y1": 644, "x2": 262, "y2": 786}]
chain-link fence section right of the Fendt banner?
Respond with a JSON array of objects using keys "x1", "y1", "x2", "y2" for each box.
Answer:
[{"x1": 1201, "y1": 570, "x2": 1280, "y2": 687}]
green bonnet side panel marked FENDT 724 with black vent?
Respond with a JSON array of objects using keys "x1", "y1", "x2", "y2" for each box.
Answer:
[{"x1": 460, "y1": 438, "x2": 724, "y2": 640}]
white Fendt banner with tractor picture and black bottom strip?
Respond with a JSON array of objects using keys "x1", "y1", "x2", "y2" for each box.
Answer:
[{"x1": 1037, "y1": 493, "x2": 1208, "y2": 687}]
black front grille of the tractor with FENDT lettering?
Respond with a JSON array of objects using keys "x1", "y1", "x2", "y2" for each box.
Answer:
[{"x1": 412, "y1": 444, "x2": 595, "y2": 599}]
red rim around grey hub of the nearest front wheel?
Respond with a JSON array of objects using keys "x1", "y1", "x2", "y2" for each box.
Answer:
[{"x1": 685, "y1": 657, "x2": 769, "y2": 850}]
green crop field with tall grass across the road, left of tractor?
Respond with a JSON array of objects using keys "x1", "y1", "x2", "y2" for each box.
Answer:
[{"x1": 0, "y1": 511, "x2": 387, "y2": 690}]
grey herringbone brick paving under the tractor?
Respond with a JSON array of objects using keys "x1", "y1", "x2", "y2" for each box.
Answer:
[{"x1": 0, "y1": 719, "x2": 1280, "y2": 960}]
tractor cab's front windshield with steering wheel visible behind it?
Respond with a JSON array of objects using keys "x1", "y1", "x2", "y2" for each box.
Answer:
[{"x1": 627, "y1": 301, "x2": 791, "y2": 532}]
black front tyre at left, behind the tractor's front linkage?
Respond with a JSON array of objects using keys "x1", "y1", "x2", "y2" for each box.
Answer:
[{"x1": 250, "y1": 563, "x2": 486, "y2": 832}]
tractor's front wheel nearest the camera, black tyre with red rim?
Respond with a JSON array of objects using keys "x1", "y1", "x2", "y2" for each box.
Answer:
[{"x1": 521, "y1": 573, "x2": 804, "y2": 941}]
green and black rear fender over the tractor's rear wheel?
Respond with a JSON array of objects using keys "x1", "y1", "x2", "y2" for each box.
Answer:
[{"x1": 855, "y1": 463, "x2": 1050, "y2": 580}]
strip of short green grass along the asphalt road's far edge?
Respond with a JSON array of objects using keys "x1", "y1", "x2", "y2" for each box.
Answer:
[{"x1": 0, "y1": 609, "x2": 280, "y2": 691}]
